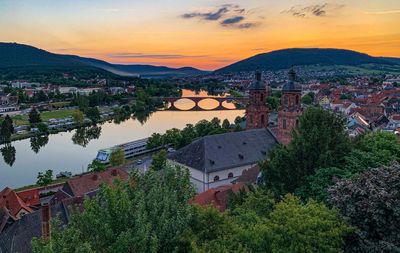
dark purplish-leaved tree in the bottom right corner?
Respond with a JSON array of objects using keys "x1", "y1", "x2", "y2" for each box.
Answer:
[{"x1": 328, "y1": 162, "x2": 400, "y2": 252}]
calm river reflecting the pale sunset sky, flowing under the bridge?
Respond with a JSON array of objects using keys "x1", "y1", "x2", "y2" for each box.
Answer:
[{"x1": 0, "y1": 91, "x2": 244, "y2": 190}]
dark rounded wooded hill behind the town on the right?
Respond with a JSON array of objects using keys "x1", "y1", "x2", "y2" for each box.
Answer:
[{"x1": 217, "y1": 48, "x2": 398, "y2": 72}]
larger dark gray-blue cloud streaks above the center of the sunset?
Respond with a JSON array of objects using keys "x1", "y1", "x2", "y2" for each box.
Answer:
[{"x1": 181, "y1": 4, "x2": 257, "y2": 29}]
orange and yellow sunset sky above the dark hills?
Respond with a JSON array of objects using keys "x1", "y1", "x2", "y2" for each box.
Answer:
[{"x1": 0, "y1": 0, "x2": 400, "y2": 70}]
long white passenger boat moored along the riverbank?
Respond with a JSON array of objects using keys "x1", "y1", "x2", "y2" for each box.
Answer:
[{"x1": 95, "y1": 138, "x2": 164, "y2": 164}]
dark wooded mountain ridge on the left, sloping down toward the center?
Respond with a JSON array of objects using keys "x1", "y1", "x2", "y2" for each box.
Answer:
[{"x1": 0, "y1": 42, "x2": 207, "y2": 77}]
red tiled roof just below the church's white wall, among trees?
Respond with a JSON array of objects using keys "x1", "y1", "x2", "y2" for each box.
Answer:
[{"x1": 190, "y1": 183, "x2": 249, "y2": 212}]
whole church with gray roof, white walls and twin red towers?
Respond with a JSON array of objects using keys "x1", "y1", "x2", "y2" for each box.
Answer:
[{"x1": 167, "y1": 69, "x2": 302, "y2": 193}]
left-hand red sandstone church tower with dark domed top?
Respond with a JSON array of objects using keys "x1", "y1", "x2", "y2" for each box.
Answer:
[{"x1": 246, "y1": 70, "x2": 268, "y2": 130}]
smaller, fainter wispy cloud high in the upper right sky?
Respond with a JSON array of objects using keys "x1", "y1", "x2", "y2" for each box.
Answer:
[{"x1": 281, "y1": 3, "x2": 344, "y2": 18}]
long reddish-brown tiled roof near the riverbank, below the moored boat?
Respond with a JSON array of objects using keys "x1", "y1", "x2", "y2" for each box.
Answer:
[{"x1": 64, "y1": 168, "x2": 129, "y2": 196}]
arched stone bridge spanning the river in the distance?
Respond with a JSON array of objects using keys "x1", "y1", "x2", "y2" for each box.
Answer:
[{"x1": 162, "y1": 97, "x2": 248, "y2": 111}]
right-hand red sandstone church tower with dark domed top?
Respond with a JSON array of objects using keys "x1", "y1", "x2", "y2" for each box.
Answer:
[{"x1": 278, "y1": 68, "x2": 302, "y2": 144}]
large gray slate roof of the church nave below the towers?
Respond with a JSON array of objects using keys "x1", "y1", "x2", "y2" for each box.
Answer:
[{"x1": 167, "y1": 128, "x2": 279, "y2": 172}]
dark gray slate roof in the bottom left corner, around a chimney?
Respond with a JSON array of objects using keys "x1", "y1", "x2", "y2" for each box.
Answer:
[{"x1": 0, "y1": 203, "x2": 66, "y2": 253}]
